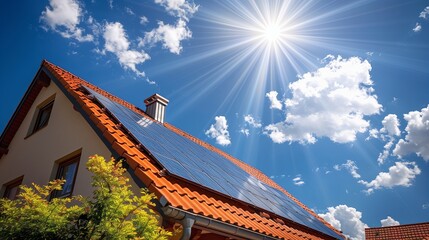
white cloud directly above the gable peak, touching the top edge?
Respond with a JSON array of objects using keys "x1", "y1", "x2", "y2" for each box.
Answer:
[{"x1": 40, "y1": 0, "x2": 94, "y2": 42}]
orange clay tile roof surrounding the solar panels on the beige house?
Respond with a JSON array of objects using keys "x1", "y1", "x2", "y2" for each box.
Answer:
[{"x1": 0, "y1": 60, "x2": 342, "y2": 239}]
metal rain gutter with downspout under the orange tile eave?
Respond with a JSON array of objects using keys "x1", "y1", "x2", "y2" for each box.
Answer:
[{"x1": 162, "y1": 206, "x2": 277, "y2": 240}]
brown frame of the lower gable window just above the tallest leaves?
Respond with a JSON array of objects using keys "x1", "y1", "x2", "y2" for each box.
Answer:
[{"x1": 50, "y1": 153, "x2": 81, "y2": 199}]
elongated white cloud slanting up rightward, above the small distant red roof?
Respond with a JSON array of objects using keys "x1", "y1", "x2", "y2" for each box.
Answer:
[{"x1": 359, "y1": 162, "x2": 421, "y2": 194}]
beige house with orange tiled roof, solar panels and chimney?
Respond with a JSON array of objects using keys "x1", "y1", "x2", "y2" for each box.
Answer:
[{"x1": 0, "y1": 61, "x2": 344, "y2": 239}]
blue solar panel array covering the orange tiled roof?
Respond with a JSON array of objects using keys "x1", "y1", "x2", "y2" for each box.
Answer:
[{"x1": 86, "y1": 88, "x2": 342, "y2": 239}]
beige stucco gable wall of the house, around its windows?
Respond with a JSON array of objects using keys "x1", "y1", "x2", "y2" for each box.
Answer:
[{"x1": 0, "y1": 81, "x2": 111, "y2": 196}]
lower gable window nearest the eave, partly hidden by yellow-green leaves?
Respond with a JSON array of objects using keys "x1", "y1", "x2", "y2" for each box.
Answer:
[{"x1": 52, "y1": 155, "x2": 80, "y2": 198}]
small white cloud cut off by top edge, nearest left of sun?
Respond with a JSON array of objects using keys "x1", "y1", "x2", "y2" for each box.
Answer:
[{"x1": 155, "y1": 0, "x2": 198, "y2": 21}]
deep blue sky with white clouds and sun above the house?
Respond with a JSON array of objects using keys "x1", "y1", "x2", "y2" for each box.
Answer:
[{"x1": 0, "y1": 0, "x2": 429, "y2": 239}]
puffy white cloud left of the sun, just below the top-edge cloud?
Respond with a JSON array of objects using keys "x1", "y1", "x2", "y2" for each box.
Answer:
[{"x1": 139, "y1": 19, "x2": 192, "y2": 54}]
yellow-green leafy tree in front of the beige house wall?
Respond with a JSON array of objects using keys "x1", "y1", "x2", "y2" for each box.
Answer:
[{"x1": 0, "y1": 155, "x2": 171, "y2": 239}]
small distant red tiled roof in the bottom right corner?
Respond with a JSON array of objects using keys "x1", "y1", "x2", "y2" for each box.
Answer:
[{"x1": 365, "y1": 222, "x2": 429, "y2": 240}]
